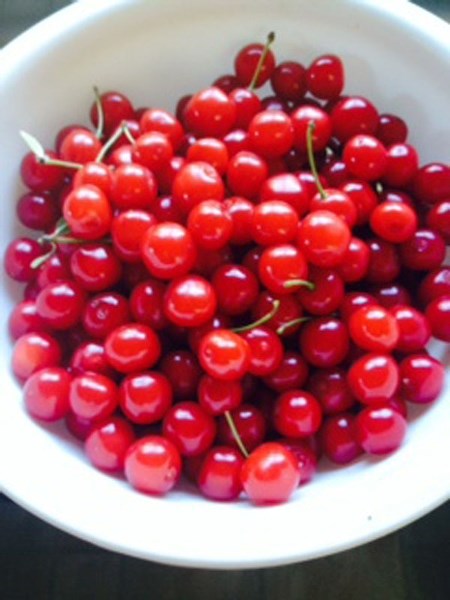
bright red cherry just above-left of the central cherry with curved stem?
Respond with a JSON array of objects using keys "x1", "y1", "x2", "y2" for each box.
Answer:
[{"x1": 164, "y1": 275, "x2": 217, "y2": 327}]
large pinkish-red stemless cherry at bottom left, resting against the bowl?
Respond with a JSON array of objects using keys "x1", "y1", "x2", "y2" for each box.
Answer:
[{"x1": 124, "y1": 435, "x2": 182, "y2": 495}]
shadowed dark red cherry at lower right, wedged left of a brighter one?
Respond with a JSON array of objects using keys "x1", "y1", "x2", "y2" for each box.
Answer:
[{"x1": 320, "y1": 413, "x2": 362, "y2": 465}]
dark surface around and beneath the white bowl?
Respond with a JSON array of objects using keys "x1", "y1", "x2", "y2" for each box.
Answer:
[{"x1": 0, "y1": 0, "x2": 450, "y2": 600}]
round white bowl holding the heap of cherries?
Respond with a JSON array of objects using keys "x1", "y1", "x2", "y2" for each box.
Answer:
[{"x1": 0, "y1": 0, "x2": 450, "y2": 568}]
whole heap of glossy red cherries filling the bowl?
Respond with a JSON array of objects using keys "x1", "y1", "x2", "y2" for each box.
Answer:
[{"x1": 5, "y1": 35, "x2": 450, "y2": 504}]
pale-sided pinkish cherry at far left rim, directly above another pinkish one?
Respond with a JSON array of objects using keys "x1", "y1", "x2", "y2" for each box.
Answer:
[{"x1": 23, "y1": 367, "x2": 71, "y2": 421}]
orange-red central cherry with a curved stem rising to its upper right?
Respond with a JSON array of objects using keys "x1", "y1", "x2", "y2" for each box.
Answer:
[{"x1": 198, "y1": 329, "x2": 250, "y2": 381}]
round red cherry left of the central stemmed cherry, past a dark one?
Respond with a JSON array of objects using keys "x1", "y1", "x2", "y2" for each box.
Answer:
[{"x1": 105, "y1": 323, "x2": 161, "y2": 373}]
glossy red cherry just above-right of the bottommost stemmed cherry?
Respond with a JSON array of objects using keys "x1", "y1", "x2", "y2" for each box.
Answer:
[{"x1": 273, "y1": 390, "x2": 322, "y2": 439}]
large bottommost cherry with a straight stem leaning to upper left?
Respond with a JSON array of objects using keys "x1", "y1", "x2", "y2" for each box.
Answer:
[{"x1": 241, "y1": 442, "x2": 300, "y2": 504}]
